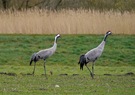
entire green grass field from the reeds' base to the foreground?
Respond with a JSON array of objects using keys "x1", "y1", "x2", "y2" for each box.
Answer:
[{"x1": 0, "y1": 35, "x2": 135, "y2": 95}]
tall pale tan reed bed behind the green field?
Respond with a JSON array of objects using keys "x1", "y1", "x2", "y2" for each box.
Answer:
[{"x1": 0, "y1": 9, "x2": 135, "y2": 34}]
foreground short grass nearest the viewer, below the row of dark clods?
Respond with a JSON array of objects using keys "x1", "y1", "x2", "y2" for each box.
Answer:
[{"x1": 0, "y1": 67, "x2": 135, "y2": 95}]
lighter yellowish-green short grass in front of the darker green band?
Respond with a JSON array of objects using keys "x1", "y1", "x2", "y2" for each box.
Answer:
[{"x1": 0, "y1": 65, "x2": 135, "y2": 95}]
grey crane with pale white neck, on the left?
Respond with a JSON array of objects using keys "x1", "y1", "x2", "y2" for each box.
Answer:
[{"x1": 30, "y1": 34, "x2": 60, "y2": 78}]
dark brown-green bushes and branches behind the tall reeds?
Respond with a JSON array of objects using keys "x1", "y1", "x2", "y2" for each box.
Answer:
[{"x1": 0, "y1": 0, "x2": 135, "y2": 12}]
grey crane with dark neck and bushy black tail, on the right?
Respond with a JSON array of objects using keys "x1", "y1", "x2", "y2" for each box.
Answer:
[{"x1": 78, "y1": 30, "x2": 112, "y2": 79}]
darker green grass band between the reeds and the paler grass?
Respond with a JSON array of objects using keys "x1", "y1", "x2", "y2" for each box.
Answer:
[{"x1": 0, "y1": 35, "x2": 135, "y2": 66}]
